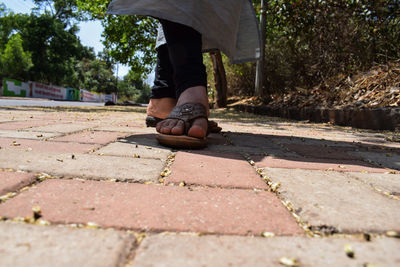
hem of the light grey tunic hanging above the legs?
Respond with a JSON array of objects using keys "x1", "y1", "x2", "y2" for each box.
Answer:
[{"x1": 108, "y1": 0, "x2": 260, "y2": 63}]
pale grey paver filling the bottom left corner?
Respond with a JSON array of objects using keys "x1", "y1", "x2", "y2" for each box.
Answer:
[{"x1": 0, "y1": 223, "x2": 135, "y2": 267}]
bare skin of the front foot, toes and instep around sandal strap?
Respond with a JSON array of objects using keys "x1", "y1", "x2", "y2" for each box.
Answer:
[{"x1": 156, "y1": 86, "x2": 209, "y2": 139}]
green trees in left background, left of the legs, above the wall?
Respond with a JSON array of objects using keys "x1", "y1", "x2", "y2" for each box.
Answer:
[{"x1": 0, "y1": 0, "x2": 155, "y2": 99}]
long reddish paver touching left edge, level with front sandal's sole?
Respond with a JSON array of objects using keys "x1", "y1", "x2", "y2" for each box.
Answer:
[{"x1": 0, "y1": 138, "x2": 98, "y2": 153}]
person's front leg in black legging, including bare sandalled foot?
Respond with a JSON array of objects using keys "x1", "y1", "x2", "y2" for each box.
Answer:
[{"x1": 157, "y1": 20, "x2": 208, "y2": 138}]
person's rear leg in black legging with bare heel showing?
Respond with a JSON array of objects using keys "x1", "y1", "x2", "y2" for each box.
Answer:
[{"x1": 147, "y1": 44, "x2": 176, "y2": 119}]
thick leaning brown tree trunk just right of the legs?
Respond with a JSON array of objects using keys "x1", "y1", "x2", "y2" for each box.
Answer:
[{"x1": 210, "y1": 51, "x2": 228, "y2": 108}]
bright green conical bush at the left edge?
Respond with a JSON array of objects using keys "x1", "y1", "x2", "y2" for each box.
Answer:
[{"x1": 0, "y1": 34, "x2": 33, "y2": 80}]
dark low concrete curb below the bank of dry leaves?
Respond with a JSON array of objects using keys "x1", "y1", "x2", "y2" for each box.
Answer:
[{"x1": 231, "y1": 105, "x2": 400, "y2": 131}]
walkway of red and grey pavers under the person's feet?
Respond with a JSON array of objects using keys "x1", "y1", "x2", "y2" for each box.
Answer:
[{"x1": 0, "y1": 107, "x2": 400, "y2": 267}]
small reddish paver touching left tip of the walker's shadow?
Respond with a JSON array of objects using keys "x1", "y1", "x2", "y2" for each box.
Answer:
[{"x1": 55, "y1": 131, "x2": 127, "y2": 145}]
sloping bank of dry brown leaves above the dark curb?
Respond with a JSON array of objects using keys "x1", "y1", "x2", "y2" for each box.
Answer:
[{"x1": 231, "y1": 60, "x2": 400, "y2": 109}]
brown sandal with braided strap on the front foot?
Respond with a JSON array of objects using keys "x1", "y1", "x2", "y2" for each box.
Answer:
[{"x1": 157, "y1": 103, "x2": 208, "y2": 149}]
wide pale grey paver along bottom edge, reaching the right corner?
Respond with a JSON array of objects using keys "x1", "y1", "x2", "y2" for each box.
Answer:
[{"x1": 128, "y1": 234, "x2": 400, "y2": 267}]
